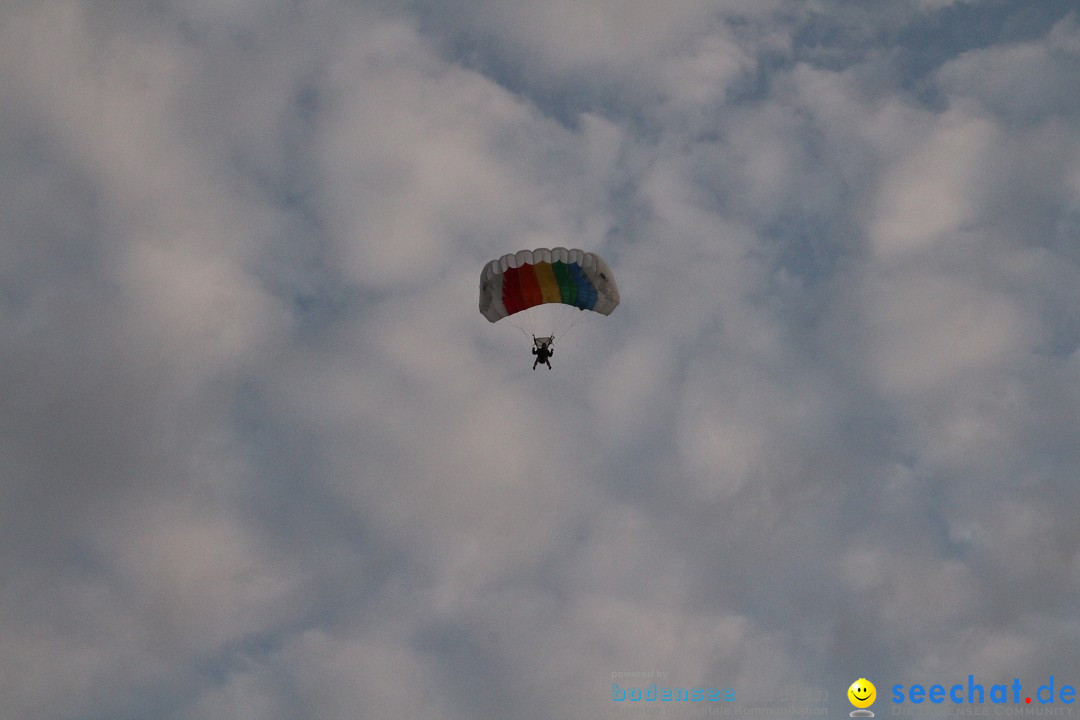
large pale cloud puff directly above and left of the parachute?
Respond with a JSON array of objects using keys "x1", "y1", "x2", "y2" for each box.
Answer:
[{"x1": 316, "y1": 16, "x2": 618, "y2": 290}]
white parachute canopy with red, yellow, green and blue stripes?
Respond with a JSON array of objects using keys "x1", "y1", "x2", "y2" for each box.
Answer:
[{"x1": 480, "y1": 247, "x2": 619, "y2": 323}]
